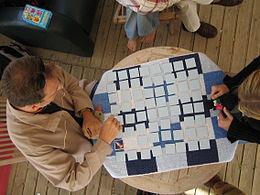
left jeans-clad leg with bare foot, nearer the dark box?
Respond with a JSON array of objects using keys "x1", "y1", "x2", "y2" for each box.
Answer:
[{"x1": 124, "y1": 7, "x2": 138, "y2": 51}]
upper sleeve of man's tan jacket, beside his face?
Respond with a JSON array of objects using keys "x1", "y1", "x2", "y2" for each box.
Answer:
[{"x1": 56, "y1": 66, "x2": 93, "y2": 113}]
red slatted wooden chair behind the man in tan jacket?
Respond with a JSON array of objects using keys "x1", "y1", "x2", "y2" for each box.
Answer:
[{"x1": 0, "y1": 97, "x2": 26, "y2": 166}]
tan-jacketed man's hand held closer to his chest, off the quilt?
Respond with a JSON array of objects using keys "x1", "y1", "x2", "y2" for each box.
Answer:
[{"x1": 82, "y1": 110, "x2": 102, "y2": 139}]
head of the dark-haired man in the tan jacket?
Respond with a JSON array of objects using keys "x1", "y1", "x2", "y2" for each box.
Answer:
[{"x1": 1, "y1": 56, "x2": 60, "y2": 111}]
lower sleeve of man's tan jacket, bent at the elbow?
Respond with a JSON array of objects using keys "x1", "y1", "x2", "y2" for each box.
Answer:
[{"x1": 26, "y1": 140, "x2": 112, "y2": 191}]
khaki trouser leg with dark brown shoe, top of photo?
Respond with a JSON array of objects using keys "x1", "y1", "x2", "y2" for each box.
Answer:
[{"x1": 176, "y1": 0, "x2": 217, "y2": 38}]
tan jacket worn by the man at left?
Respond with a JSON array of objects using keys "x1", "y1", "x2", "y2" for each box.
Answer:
[{"x1": 6, "y1": 66, "x2": 112, "y2": 191}]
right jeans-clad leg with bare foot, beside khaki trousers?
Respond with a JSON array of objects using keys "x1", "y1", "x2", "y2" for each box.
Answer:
[{"x1": 137, "y1": 12, "x2": 160, "y2": 43}]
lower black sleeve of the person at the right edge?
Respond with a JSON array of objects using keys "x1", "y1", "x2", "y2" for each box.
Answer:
[{"x1": 227, "y1": 117, "x2": 260, "y2": 144}]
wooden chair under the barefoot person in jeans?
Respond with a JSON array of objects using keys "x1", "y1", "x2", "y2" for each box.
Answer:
[{"x1": 113, "y1": 4, "x2": 178, "y2": 33}]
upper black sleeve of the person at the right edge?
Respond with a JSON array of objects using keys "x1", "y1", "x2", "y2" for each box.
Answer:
[{"x1": 223, "y1": 56, "x2": 260, "y2": 90}]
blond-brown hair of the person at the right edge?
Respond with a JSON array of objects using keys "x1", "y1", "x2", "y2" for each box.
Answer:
[{"x1": 238, "y1": 70, "x2": 260, "y2": 120}]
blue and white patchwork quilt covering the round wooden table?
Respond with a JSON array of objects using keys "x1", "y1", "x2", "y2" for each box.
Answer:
[{"x1": 93, "y1": 53, "x2": 237, "y2": 178}]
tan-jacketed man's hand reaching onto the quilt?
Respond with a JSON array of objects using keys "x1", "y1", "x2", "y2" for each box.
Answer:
[{"x1": 99, "y1": 116, "x2": 122, "y2": 144}]
